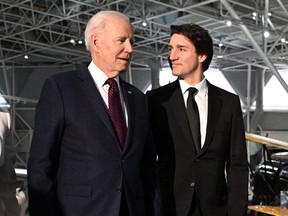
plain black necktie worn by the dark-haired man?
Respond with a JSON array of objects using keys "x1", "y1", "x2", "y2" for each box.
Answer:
[{"x1": 187, "y1": 88, "x2": 201, "y2": 152}]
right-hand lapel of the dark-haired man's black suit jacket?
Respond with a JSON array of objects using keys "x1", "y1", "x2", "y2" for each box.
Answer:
[{"x1": 200, "y1": 81, "x2": 222, "y2": 152}]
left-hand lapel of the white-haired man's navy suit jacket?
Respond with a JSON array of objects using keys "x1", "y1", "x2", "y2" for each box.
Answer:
[{"x1": 78, "y1": 68, "x2": 119, "y2": 146}]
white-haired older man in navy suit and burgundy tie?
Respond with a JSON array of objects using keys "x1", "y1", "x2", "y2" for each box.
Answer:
[{"x1": 28, "y1": 11, "x2": 155, "y2": 216}]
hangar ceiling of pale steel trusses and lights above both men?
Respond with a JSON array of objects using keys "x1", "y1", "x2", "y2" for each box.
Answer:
[{"x1": 0, "y1": 0, "x2": 288, "y2": 70}]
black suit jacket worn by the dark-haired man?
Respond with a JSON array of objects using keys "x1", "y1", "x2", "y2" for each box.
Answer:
[{"x1": 147, "y1": 80, "x2": 248, "y2": 216}]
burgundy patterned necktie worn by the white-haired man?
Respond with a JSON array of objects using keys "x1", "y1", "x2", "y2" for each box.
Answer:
[{"x1": 107, "y1": 78, "x2": 127, "y2": 148}]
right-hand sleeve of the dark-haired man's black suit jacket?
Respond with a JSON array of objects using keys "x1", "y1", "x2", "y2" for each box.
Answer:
[{"x1": 227, "y1": 97, "x2": 249, "y2": 216}]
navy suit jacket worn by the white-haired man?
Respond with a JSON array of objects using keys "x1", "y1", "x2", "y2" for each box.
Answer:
[{"x1": 28, "y1": 68, "x2": 156, "y2": 216}]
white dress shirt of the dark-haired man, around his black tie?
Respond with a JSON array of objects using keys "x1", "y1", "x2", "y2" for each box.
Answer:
[{"x1": 179, "y1": 78, "x2": 208, "y2": 147}]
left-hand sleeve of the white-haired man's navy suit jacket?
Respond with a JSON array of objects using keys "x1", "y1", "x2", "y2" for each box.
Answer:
[{"x1": 28, "y1": 78, "x2": 64, "y2": 216}]
